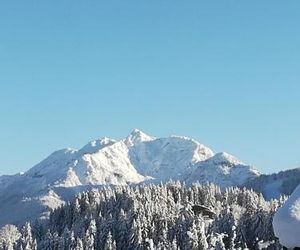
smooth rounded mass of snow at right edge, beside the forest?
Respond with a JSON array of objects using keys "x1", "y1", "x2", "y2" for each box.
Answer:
[{"x1": 273, "y1": 185, "x2": 300, "y2": 249}]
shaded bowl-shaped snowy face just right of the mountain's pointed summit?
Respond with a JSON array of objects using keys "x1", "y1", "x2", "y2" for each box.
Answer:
[{"x1": 130, "y1": 136, "x2": 213, "y2": 181}]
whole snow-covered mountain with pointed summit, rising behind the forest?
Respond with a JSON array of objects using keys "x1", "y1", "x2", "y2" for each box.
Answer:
[{"x1": 0, "y1": 129, "x2": 260, "y2": 225}]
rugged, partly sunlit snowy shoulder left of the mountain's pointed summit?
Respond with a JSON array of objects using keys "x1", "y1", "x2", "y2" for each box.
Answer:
[{"x1": 25, "y1": 135, "x2": 145, "y2": 187}]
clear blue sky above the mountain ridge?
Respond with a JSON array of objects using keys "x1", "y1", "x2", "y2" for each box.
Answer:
[{"x1": 0, "y1": 0, "x2": 300, "y2": 174}]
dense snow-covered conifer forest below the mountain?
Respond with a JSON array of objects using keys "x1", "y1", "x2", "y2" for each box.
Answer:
[{"x1": 0, "y1": 182, "x2": 285, "y2": 250}]
